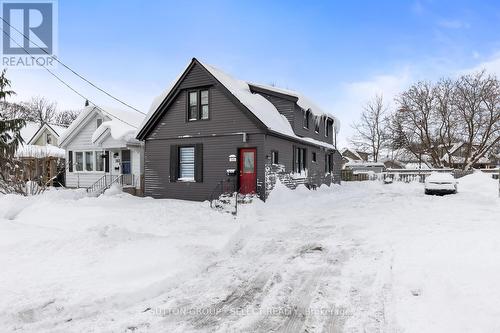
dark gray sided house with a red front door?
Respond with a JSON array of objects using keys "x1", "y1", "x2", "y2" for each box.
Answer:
[{"x1": 137, "y1": 59, "x2": 342, "y2": 201}]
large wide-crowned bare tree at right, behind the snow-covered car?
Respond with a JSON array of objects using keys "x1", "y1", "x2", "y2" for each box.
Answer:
[{"x1": 389, "y1": 72, "x2": 500, "y2": 169}]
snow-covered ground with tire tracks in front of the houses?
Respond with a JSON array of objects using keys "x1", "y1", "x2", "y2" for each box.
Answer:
[{"x1": 0, "y1": 173, "x2": 500, "y2": 332}]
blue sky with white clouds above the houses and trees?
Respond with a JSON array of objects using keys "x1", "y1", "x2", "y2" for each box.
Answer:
[{"x1": 9, "y1": 0, "x2": 500, "y2": 144}]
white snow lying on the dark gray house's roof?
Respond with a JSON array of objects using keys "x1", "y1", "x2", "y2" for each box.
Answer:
[{"x1": 139, "y1": 61, "x2": 337, "y2": 149}]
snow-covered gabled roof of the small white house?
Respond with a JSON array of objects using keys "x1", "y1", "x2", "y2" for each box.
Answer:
[{"x1": 60, "y1": 105, "x2": 144, "y2": 145}]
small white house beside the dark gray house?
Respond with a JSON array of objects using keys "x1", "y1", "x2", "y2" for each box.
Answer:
[{"x1": 59, "y1": 106, "x2": 144, "y2": 194}]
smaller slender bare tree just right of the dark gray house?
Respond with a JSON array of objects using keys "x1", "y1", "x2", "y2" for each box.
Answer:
[{"x1": 350, "y1": 95, "x2": 387, "y2": 162}]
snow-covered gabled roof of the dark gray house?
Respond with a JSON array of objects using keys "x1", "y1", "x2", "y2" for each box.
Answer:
[{"x1": 137, "y1": 58, "x2": 335, "y2": 149}]
